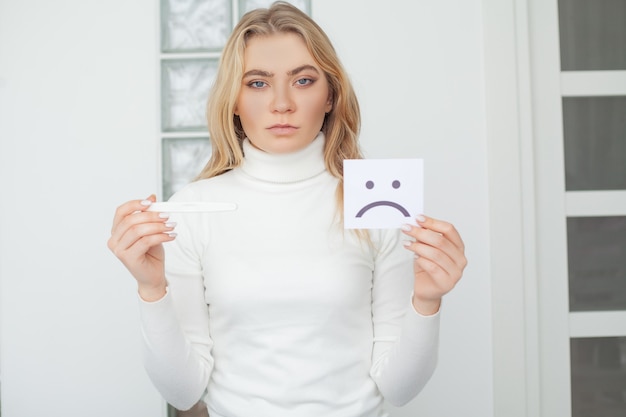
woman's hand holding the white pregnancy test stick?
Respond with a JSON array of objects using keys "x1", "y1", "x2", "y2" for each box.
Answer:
[{"x1": 107, "y1": 195, "x2": 176, "y2": 301}]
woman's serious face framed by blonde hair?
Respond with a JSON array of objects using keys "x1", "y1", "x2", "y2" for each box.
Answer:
[{"x1": 235, "y1": 33, "x2": 332, "y2": 153}]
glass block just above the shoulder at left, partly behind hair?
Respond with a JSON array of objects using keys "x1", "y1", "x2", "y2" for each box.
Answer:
[{"x1": 162, "y1": 137, "x2": 211, "y2": 200}]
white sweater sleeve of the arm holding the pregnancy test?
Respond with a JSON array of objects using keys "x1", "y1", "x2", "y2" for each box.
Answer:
[{"x1": 139, "y1": 210, "x2": 213, "y2": 410}]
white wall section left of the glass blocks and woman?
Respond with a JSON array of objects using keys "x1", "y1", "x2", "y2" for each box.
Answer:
[{"x1": 0, "y1": 0, "x2": 162, "y2": 417}]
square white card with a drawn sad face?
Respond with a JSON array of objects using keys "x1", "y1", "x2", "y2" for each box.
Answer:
[{"x1": 343, "y1": 159, "x2": 424, "y2": 229}]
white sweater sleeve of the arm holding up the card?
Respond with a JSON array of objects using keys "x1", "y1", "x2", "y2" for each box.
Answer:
[{"x1": 370, "y1": 230, "x2": 440, "y2": 406}]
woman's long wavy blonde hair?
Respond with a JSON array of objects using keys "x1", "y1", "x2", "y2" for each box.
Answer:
[{"x1": 198, "y1": 1, "x2": 362, "y2": 207}]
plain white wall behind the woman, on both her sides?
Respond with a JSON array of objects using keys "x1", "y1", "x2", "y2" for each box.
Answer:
[{"x1": 0, "y1": 0, "x2": 493, "y2": 417}]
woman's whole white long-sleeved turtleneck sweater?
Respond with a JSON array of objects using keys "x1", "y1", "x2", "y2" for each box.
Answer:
[{"x1": 140, "y1": 134, "x2": 439, "y2": 417}]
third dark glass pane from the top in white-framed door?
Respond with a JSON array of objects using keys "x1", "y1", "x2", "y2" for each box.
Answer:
[{"x1": 567, "y1": 216, "x2": 626, "y2": 311}]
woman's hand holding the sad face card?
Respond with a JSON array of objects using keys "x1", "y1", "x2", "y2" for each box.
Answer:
[{"x1": 402, "y1": 216, "x2": 467, "y2": 315}]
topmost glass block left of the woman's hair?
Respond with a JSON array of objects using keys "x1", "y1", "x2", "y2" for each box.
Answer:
[{"x1": 161, "y1": 0, "x2": 232, "y2": 52}]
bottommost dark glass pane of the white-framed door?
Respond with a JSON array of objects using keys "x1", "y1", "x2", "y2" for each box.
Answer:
[{"x1": 570, "y1": 337, "x2": 626, "y2": 417}]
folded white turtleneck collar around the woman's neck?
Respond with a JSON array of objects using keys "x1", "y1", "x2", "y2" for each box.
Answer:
[{"x1": 241, "y1": 132, "x2": 326, "y2": 184}]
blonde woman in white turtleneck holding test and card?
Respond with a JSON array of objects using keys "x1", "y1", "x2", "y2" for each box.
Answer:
[{"x1": 109, "y1": 2, "x2": 466, "y2": 417}]
